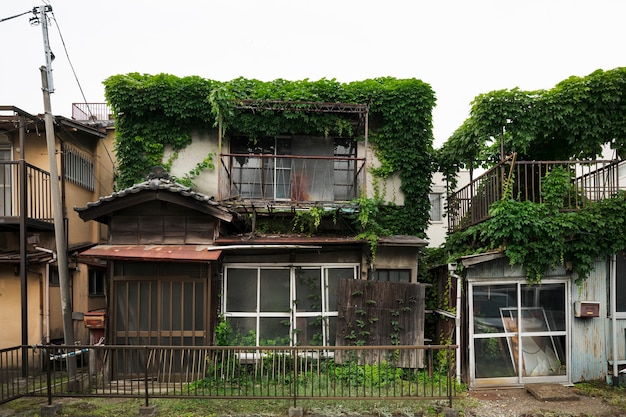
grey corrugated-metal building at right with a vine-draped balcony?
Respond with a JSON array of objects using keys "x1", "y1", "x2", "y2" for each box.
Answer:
[{"x1": 439, "y1": 155, "x2": 626, "y2": 387}]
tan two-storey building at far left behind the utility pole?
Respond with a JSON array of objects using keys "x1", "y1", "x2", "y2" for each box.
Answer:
[{"x1": 0, "y1": 106, "x2": 113, "y2": 348}]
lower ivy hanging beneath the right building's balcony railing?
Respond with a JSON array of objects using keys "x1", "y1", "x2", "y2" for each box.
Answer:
[{"x1": 445, "y1": 169, "x2": 626, "y2": 284}]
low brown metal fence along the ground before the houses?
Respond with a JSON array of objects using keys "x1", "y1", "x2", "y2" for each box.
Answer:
[{"x1": 0, "y1": 345, "x2": 458, "y2": 407}]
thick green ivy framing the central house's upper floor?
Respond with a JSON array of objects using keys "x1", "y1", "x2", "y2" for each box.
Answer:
[{"x1": 104, "y1": 73, "x2": 435, "y2": 240}]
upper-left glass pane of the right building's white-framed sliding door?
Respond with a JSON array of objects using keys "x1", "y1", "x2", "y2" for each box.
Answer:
[{"x1": 473, "y1": 284, "x2": 517, "y2": 334}]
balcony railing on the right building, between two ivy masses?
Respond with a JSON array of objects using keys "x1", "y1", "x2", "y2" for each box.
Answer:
[{"x1": 447, "y1": 157, "x2": 626, "y2": 232}]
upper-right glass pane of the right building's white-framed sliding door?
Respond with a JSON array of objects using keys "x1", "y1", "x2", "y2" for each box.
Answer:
[{"x1": 521, "y1": 283, "x2": 565, "y2": 332}]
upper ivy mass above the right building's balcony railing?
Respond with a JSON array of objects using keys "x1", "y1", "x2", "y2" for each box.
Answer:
[{"x1": 437, "y1": 68, "x2": 626, "y2": 178}]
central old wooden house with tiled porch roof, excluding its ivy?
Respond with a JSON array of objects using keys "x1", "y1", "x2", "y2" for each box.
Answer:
[{"x1": 76, "y1": 103, "x2": 427, "y2": 374}]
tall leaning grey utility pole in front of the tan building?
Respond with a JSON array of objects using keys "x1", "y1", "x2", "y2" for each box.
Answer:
[{"x1": 33, "y1": 5, "x2": 76, "y2": 387}]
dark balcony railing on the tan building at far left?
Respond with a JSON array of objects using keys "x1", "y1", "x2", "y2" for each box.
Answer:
[{"x1": 0, "y1": 161, "x2": 53, "y2": 223}]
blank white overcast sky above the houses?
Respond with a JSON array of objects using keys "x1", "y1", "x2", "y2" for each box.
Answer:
[{"x1": 0, "y1": 0, "x2": 626, "y2": 147}]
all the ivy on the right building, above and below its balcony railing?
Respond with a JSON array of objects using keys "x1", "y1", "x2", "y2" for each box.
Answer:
[{"x1": 436, "y1": 68, "x2": 626, "y2": 283}]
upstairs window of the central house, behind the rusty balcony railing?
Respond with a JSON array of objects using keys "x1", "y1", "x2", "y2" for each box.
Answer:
[{"x1": 230, "y1": 136, "x2": 358, "y2": 202}]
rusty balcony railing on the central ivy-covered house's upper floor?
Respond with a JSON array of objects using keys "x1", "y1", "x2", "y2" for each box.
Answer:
[{"x1": 220, "y1": 154, "x2": 365, "y2": 204}]
